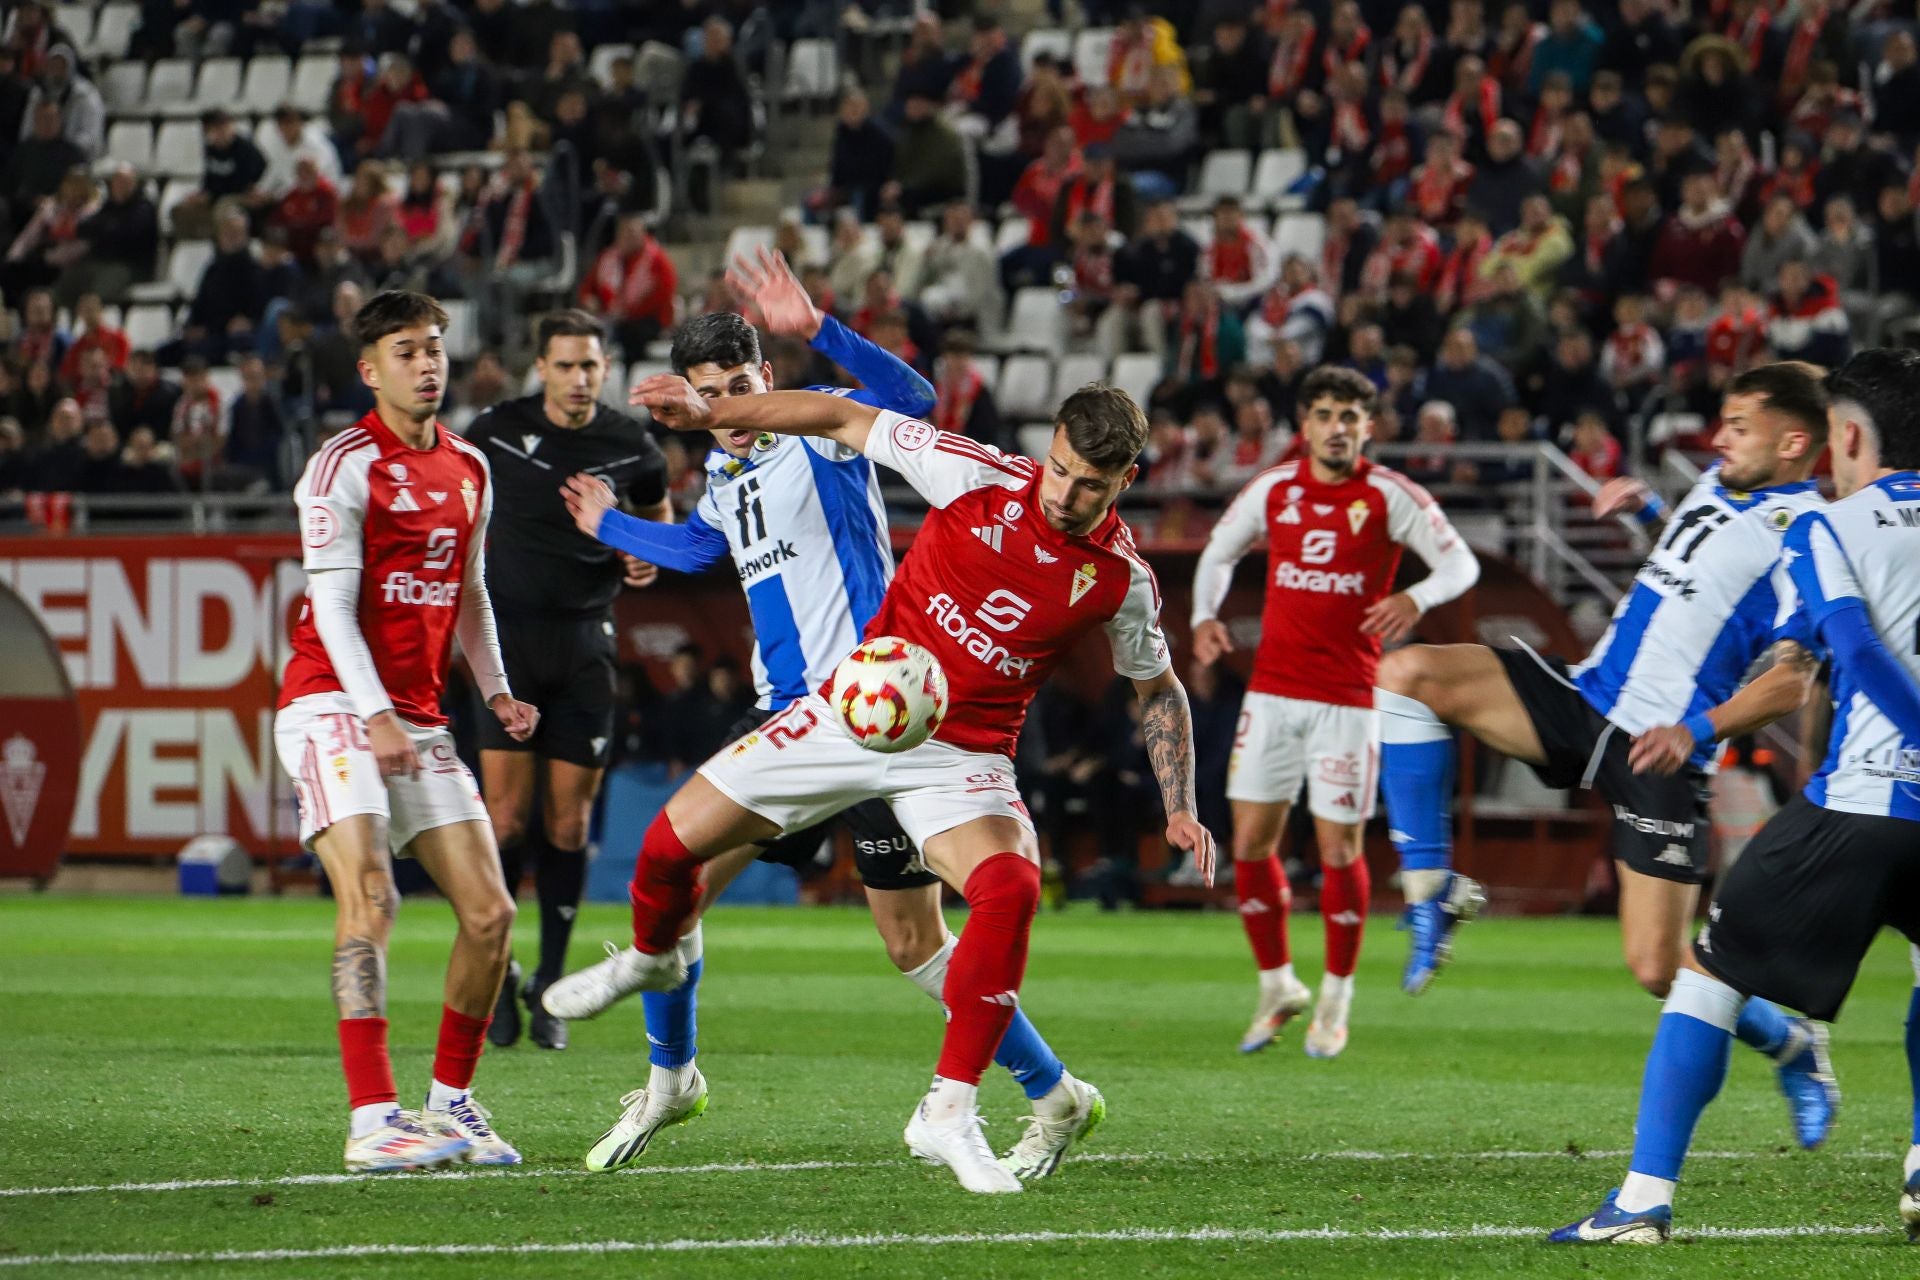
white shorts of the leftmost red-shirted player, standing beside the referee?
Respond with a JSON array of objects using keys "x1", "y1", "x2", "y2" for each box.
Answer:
[{"x1": 273, "y1": 693, "x2": 488, "y2": 854}]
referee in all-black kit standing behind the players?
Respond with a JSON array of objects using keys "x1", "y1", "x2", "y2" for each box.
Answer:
[{"x1": 467, "y1": 311, "x2": 674, "y2": 1050}]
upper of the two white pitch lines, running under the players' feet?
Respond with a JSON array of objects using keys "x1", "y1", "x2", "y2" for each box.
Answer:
[{"x1": 0, "y1": 1148, "x2": 1897, "y2": 1199}]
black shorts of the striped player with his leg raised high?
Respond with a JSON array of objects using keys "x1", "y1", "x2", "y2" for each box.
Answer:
[{"x1": 1494, "y1": 649, "x2": 1713, "y2": 885}]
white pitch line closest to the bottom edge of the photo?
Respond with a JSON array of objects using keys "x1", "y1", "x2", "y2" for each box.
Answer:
[{"x1": 0, "y1": 1224, "x2": 1893, "y2": 1267}]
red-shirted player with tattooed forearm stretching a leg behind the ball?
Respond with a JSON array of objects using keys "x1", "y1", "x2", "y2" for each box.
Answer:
[{"x1": 545, "y1": 376, "x2": 1213, "y2": 1194}]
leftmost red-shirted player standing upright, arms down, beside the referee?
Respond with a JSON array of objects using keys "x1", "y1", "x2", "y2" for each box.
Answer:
[{"x1": 273, "y1": 290, "x2": 540, "y2": 1173}]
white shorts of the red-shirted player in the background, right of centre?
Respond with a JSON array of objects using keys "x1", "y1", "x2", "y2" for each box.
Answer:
[{"x1": 1227, "y1": 693, "x2": 1380, "y2": 823}]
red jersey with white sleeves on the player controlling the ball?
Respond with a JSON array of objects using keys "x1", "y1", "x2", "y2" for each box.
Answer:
[{"x1": 837, "y1": 413, "x2": 1169, "y2": 756}]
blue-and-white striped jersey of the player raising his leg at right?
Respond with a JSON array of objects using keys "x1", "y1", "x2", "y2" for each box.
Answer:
[{"x1": 1572, "y1": 468, "x2": 1822, "y2": 764}]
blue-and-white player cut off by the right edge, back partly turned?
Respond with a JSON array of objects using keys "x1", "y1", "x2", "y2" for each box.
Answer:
[{"x1": 1549, "y1": 349, "x2": 1920, "y2": 1244}]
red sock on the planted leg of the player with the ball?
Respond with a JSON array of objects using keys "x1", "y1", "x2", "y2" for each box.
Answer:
[{"x1": 937, "y1": 854, "x2": 1041, "y2": 1084}]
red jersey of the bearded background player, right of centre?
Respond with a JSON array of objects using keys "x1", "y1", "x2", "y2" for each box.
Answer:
[{"x1": 1192, "y1": 459, "x2": 1480, "y2": 706}]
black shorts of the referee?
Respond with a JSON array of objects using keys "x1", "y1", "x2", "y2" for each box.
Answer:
[{"x1": 480, "y1": 610, "x2": 614, "y2": 770}]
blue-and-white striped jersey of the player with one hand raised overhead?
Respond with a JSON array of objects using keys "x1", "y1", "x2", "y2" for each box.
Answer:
[{"x1": 599, "y1": 317, "x2": 933, "y2": 710}]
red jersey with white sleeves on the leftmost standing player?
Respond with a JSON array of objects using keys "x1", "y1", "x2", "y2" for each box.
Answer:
[{"x1": 278, "y1": 413, "x2": 493, "y2": 725}]
